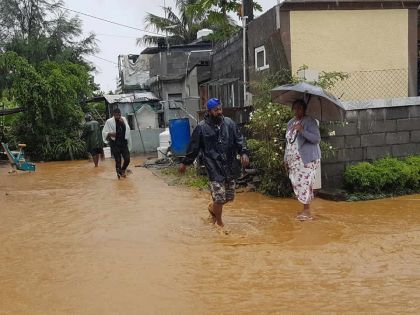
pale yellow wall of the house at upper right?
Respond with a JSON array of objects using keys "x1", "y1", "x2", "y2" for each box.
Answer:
[{"x1": 290, "y1": 9, "x2": 409, "y2": 99}]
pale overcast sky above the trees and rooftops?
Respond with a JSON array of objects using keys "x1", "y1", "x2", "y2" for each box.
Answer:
[{"x1": 65, "y1": 0, "x2": 277, "y2": 92}]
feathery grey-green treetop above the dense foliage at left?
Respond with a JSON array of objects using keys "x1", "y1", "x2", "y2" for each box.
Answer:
[{"x1": 0, "y1": 0, "x2": 97, "y2": 68}]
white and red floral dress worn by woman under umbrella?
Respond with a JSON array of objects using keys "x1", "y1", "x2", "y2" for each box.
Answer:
[{"x1": 285, "y1": 120, "x2": 320, "y2": 204}]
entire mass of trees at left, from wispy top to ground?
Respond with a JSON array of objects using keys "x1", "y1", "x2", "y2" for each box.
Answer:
[{"x1": 0, "y1": 0, "x2": 101, "y2": 160}]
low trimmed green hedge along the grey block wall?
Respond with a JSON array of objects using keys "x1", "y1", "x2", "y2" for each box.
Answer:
[{"x1": 344, "y1": 156, "x2": 420, "y2": 195}]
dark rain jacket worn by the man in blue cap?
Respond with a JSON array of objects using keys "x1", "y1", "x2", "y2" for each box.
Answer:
[{"x1": 183, "y1": 113, "x2": 247, "y2": 182}]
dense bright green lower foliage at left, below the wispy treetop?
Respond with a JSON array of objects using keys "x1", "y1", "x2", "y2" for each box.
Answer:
[{"x1": 0, "y1": 52, "x2": 92, "y2": 160}]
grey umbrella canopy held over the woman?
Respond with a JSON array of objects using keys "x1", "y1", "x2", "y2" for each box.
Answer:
[{"x1": 271, "y1": 82, "x2": 345, "y2": 122}]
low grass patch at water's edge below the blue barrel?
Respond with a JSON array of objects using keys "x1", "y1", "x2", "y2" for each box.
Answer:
[{"x1": 160, "y1": 166, "x2": 209, "y2": 190}]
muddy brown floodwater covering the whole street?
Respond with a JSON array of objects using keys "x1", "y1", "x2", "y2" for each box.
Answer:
[{"x1": 0, "y1": 159, "x2": 420, "y2": 314}]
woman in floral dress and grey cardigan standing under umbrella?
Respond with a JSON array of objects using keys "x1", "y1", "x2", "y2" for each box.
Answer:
[{"x1": 284, "y1": 100, "x2": 321, "y2": 221}]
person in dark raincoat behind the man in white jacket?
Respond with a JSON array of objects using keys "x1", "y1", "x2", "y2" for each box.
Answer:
[{"x1": 82, "y1": 114, "x2": 104, "y2": 167}]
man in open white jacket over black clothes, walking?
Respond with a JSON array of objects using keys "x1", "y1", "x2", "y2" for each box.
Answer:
[{"x1": 102, "y1": 108, "x2": 131, "y2": 179}]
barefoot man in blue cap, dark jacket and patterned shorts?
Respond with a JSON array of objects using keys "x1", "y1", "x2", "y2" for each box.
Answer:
[{"x1": 179, "y1": 98, "x2": 249, "y2": 228}]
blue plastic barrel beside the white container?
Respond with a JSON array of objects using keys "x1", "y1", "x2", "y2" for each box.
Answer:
[{"x1": 169, "y1": 118, "x2": 190, "y2": 156}]
